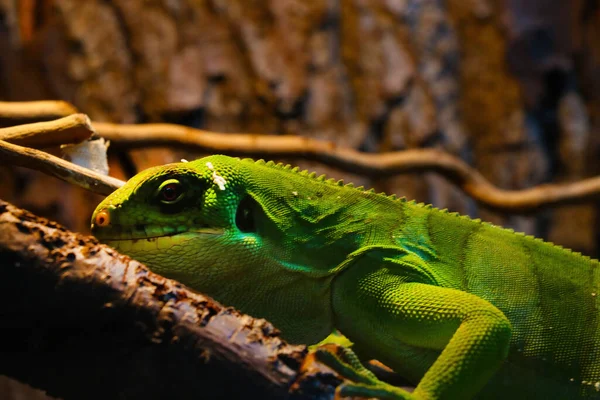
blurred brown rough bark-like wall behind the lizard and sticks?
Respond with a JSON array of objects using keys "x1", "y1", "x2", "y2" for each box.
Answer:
[{"x1": 0, "y1": 0, "x2": 600, "y2": 399}]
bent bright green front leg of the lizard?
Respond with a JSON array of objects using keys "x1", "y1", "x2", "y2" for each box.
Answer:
[{"x1": 332, "y1": 257, "x2": 511, "y2": 399}]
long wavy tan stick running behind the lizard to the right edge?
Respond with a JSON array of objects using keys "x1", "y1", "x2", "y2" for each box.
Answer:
[{"x1": 94, "y1": 123, "x2": 600, "y2": 213}]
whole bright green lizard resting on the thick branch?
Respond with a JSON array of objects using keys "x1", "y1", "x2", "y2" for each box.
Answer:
[{"x1": 92, "y1": 155, "x2": 600, "y2": 399}]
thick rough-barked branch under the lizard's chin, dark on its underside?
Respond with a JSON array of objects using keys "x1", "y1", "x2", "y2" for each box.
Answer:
[{"x1": 0, "y1": 201, "x2": 341, "y2": 400}]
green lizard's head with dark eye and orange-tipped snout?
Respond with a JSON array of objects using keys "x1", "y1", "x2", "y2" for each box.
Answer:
[{"x1": 91, "y1": 156, "x2": 255, "y2": 291}]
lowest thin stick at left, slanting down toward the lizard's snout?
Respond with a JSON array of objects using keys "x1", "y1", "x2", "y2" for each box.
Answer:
[{"x1": 0, "y1": 140, "x2": 125, "y2": 195}]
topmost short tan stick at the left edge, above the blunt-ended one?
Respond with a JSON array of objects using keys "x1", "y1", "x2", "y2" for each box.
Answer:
[{"x1": 0, "y1": 100, "x2": 78, "y2": 121}]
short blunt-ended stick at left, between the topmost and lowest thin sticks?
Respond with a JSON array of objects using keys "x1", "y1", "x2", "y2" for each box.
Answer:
[{"x1": 0, "y1": 112, "x2": 95, "y2": 148}]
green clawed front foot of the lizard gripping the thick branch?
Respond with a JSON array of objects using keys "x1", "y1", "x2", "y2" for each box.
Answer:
[{"x1": 314, "y1": 344, "x2": 415, "y2": 400}]
